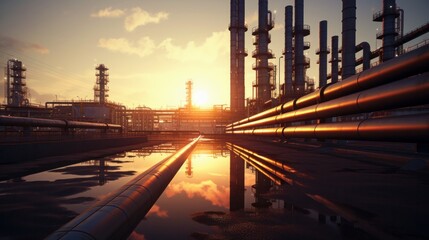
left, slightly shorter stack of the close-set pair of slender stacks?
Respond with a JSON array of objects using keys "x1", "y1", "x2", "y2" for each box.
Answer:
[{"x1": 283, "y1": 5, "x2": 295, "y2": 101}]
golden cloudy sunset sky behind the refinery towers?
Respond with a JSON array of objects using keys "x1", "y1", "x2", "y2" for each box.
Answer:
[{"x1": 0, "y1": 0, "x2": 429, "y2": 109}]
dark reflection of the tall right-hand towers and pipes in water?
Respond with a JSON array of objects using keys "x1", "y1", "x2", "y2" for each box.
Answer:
[{"x1": 219, "y1": 143, "x2": 372, "y2": 239}]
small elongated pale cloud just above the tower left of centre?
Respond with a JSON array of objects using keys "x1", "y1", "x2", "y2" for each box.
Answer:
[{"x1": 98, "y1": 37, "x2": 156, "y2": 57}]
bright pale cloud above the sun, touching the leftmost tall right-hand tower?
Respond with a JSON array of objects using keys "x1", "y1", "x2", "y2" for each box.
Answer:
[{"x1": 160, "y1": 31, "x2": 229, "y2": 63}]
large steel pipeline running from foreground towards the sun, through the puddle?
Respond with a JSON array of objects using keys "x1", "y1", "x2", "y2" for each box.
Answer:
[{"x1": 47, "y1": 137, "x2": 200, "y2": 239}]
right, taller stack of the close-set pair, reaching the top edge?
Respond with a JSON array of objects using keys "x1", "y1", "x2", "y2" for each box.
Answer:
[{"x1": 294, "y1": 0, "x2": 305, "y2": 97}]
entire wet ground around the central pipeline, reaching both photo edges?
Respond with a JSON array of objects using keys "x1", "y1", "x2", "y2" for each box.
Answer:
[{"x1": 0, "y1": 139, "x2": 429, "y2": 239}]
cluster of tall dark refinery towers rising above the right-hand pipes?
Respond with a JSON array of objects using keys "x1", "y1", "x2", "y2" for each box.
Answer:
[{"x1": 230, "y1": 0, "x2": 429, "y2": 118}]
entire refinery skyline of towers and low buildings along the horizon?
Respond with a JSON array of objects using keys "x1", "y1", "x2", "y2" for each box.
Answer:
[{"x1": 0, "y1": 0, "x2": 429, "y2": 133}]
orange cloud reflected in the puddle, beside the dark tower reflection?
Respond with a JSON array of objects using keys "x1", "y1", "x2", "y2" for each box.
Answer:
[{"x1": 165, "y1": 180, "x2": 229, "y2": 208}]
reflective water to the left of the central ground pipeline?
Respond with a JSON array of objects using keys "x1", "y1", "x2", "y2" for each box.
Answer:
[{"x1": 0, "y1": 145, "x2": 174, "y2": 239}]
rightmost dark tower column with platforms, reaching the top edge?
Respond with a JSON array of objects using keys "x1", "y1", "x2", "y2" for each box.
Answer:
[{"x1": 383, "y1": 0, "x2": 396, "y2": 62}]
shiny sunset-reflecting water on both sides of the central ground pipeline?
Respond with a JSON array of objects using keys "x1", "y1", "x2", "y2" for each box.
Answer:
[{"x1": 0, "y1": 140, "x2": 374, "y2": 240}]
